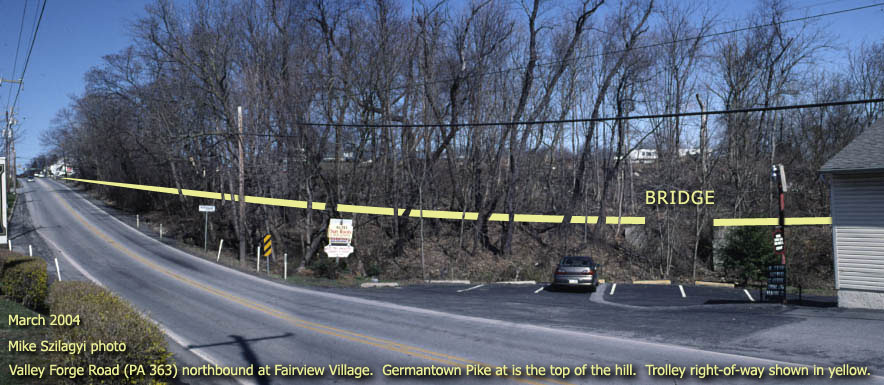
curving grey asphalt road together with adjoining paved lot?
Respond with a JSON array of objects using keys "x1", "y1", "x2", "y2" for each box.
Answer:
[{"x1": 15, "y1": 179, "x2": 884, "y2": 384}]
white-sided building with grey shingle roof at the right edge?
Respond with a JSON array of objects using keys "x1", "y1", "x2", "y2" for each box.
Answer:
[{"x1": 820, "y1": 119, "x2": 884, "y2": 309}]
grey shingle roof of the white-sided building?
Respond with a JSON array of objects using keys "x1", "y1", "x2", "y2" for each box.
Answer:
[{"x1": 820, "y1": 119, "x2": 884, "y2": 173}]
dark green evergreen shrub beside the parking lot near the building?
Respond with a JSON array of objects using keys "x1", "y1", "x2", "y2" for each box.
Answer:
[{"x1": 721, "y1": 227, "x2": 775, "y2": 285}]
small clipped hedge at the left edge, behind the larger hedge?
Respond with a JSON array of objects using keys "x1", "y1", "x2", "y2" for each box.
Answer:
[{"x1": 0, "y1": 254, "x2": 49, "y2": 311}]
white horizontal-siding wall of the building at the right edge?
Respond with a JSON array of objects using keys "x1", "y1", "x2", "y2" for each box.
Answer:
[{"x1": 832, "y1": 173, "x2": 884, "y2": 292}]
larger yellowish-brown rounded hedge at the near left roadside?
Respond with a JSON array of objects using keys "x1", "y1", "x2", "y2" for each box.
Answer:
[{"x1": 47, "y1": 281, "x2": 171, "y2": 384}]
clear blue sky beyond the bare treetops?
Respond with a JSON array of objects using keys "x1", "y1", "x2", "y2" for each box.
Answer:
[{"x1": 0, "y1": 0, "x2": 884, "y2": 172}]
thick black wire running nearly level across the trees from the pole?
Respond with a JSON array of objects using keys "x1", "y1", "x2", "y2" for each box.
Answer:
[{"x1": 176, "y1": 98, "x2": 884, "y2": 138}]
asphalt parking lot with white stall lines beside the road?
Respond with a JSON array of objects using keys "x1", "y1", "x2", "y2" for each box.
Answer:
[{"x1": 325, "y1": 283, "x2": 884, "y2": 372}]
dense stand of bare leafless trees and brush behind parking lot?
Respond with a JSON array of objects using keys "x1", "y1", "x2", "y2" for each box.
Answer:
[{"x1": 34, "y1": 0, "x2": 884, "y2": 285}]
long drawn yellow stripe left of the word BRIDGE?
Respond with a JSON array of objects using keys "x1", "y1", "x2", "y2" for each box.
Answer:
[{"x1": 63, "y1": 178, "x2": 645, "y2": 225}]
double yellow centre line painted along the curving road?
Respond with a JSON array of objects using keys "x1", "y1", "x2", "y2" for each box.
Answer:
[{"x1": 55, "y1": 186, "x2": 570, "y2": 385}]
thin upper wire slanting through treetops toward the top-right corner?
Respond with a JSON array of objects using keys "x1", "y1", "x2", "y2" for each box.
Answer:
[{"x1": 298, "y1": 2, "x2": 884, "y2": 106}]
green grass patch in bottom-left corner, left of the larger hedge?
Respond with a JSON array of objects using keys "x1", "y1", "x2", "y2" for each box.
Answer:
[{"x1": 0, "y1": 298, "x2": 52, "y2": 385}]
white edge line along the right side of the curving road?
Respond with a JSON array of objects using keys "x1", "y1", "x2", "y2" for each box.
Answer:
[{"x1": 48, "y1": 178, "x2": 884, "y2": 380}]
